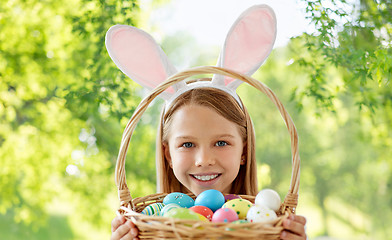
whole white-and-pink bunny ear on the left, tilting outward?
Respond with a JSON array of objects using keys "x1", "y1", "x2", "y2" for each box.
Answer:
[{"x1": 105, "y1": 25, "x2": 179, "y2": 100}]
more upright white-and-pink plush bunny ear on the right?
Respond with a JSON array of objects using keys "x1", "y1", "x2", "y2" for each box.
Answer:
[{"x1": 213, "y1": 4, "x2": 276, "y2": 89}]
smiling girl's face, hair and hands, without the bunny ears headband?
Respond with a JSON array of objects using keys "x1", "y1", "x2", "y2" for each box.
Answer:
[{"x1": 112, "y1": 88, "x2": 306, "y2": 240}]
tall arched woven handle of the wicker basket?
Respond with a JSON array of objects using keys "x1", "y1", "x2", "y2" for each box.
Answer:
[{"x1": 115, "y1": 66, "x2": 300, "y2": 214}]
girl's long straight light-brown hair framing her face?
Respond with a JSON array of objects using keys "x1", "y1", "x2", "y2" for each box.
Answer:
[{"x1": 156, "y1": 87, "x2": 258, "y2": 195}]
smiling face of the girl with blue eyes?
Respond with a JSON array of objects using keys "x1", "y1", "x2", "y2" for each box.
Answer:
[{"x1": 164, "y1": 105, "x2": 244, "y2": 195}]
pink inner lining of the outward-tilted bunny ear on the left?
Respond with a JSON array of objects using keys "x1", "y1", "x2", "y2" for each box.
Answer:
[{"x1": 111, "y1": 29, "x2": 174, "y2": 92}]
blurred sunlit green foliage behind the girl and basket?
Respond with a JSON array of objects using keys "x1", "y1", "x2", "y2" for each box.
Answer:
[{"x1": 0, "y1": 0, "x2": 392, "y2": 240}]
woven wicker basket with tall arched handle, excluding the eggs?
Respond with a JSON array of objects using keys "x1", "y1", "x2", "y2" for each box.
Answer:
[{"x1": 115, "y1": 66, "x2": 300, "y2": 239}]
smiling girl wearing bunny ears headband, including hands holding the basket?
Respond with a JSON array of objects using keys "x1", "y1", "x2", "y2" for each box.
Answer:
[{"x1": 106, "y1": 5, "x2": 306, "y2": 240}]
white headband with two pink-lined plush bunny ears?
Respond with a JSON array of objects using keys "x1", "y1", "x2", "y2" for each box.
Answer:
[{"x1": 105, "y1": 5, "x2": 276, "y2": 106}]
